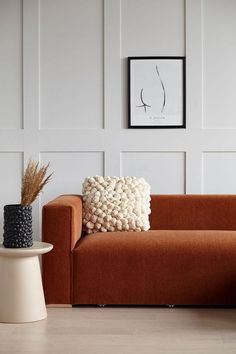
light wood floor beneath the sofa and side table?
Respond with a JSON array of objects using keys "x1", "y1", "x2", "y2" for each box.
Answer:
[{"x1": 0, "y1": 307, "x2": 236, "y2": 354}]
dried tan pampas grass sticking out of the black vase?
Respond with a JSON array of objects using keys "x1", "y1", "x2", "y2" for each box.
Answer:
[{"x1": 21, "y1": 160, "x2": 52, "y2": 206}]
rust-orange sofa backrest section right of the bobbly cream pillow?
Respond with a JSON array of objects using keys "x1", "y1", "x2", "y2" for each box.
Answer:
[{"x1": 150, "y1": 195, "x2": 236, "y2": 230}]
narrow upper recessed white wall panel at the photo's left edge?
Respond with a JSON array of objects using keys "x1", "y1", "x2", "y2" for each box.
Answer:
[{"x1": 0, "y1": 0, "x2": 23, "y2": 129}]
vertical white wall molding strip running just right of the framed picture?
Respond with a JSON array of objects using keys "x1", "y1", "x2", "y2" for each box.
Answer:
[{"x1": 185, "y1": 0, "x2": 203, "y2": 194}]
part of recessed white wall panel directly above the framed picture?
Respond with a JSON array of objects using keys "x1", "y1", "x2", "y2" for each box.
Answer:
[{"x1": 121, "y1": 0, "x2": 185, "y2": 57}]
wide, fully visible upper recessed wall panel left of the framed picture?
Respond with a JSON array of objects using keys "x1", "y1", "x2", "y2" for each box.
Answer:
[{"x1": 40, "y1": 0, "x2": 103, "y2": 129}]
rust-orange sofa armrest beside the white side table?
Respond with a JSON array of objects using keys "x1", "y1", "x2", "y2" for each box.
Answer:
[{"x1": 42, "y1": 195, "x2": 82, "y2": 304}]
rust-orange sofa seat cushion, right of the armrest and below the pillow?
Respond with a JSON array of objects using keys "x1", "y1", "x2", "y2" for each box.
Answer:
[{"x1": 72, "y1": 230, "x2": 236, "y2": 305}]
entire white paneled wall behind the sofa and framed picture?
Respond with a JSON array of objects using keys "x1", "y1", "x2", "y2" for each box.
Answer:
[{"x1": 0, "y1": 0, "x2": 236, "y2": 238}]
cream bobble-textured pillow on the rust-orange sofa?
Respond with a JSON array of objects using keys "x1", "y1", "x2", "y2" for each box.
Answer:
[{"x1": 83, "y1": 176, "x2": 151, "y2": 234}]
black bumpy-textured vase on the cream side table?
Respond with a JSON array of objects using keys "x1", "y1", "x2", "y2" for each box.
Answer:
[{"x1": 3, "y1": 204, "x2": 33, "y2": 248}]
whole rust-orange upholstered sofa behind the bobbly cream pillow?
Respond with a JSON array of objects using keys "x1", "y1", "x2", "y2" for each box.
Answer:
[{"x1": 43, "y1": 195, "x2": 236, "y2": 305}]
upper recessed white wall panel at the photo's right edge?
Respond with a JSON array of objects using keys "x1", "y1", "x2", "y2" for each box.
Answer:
[{"x1": 203, "y1": 0, "x2": 236, "y2": 129}]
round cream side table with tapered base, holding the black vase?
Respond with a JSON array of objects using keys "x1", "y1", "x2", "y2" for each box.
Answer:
[{"x1": 0, "y1": 241, "x2": 53, "y2": 323}]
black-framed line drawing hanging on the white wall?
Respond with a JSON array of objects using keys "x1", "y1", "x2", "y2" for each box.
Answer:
[{"x1": 128, "y1": 57, "x2": 186, "y2": 128}]
